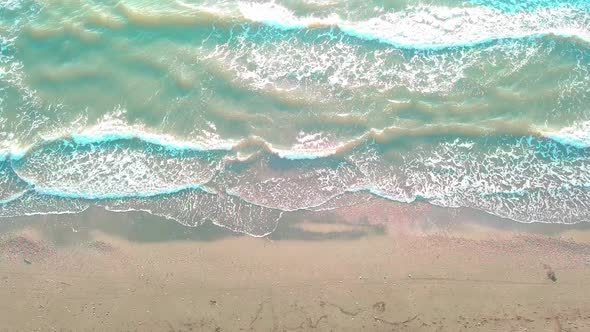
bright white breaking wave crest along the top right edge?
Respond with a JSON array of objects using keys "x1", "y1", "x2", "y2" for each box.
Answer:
[{"x1": 239, "y1": 2, "x2": 590, "y2": 50}]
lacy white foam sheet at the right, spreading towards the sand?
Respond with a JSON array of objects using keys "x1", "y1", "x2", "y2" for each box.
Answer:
[{"x1": 351, "y1": 137, "x2": 590, "y2": 223}]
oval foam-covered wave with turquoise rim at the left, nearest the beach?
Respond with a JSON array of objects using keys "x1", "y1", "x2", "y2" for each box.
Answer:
[{"x1": 11, "y1": 137, "x2": 223, "y2": 199}]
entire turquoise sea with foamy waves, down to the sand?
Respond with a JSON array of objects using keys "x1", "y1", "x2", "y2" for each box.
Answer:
[{"x1": 0, "y1": 0, "x2": 590, "y2": 236}]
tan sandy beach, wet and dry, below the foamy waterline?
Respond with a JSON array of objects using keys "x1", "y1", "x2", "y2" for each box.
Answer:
[{"x1": 0, "y1": 201, "x2": 590, "y2": 332}]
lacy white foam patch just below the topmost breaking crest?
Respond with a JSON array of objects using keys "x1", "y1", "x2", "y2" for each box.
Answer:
[{"x1": 208, "y1": 23, "x2": 549, "y2": 94}]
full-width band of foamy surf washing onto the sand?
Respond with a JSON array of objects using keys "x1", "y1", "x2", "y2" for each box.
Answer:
[{"x1": 0, "y1": 124, "x2": 590, "y2": 228}]
